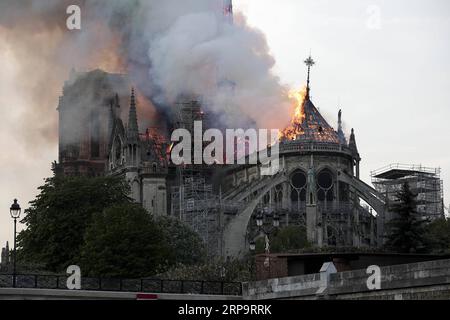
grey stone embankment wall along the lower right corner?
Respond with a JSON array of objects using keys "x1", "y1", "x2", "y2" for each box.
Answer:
[{"x1": 243, "y1": 259, "x2": 450, "y2": 300}]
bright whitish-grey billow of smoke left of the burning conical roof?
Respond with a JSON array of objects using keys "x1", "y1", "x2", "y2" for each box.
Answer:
[{"x1": 144, "y1": 1, "x2": 289, "y2": 128}]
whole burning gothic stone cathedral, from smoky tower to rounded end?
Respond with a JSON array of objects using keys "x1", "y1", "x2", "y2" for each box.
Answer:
[{"x1": 55, "y1": 58, "x2": 387, "y2": 257}]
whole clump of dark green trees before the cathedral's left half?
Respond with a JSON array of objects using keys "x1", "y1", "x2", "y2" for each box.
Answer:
[{"x1": 18, "y1": 177, "x2": 209, "y2": 277}]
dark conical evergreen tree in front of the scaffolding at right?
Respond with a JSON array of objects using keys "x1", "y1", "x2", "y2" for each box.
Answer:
[{"x1": 385, "y1": 183, "x2": 427, "y2": 253}]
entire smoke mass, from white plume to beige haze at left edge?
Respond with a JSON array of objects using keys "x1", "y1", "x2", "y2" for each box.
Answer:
[{"x1": 0, "y1": 0, "x2": 289, "y2": 246}]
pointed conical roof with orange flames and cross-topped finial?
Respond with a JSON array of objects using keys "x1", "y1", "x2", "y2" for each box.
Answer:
[{"x1": 282, "y1": 57, "x2": 345, "y2": 144}]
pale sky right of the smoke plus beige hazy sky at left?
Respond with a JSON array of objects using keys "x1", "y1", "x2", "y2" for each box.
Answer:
[{"x1": 0, "y1": 0, "x2": 450, "y2": 245}]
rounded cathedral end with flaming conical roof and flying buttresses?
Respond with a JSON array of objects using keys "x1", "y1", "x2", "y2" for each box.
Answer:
[{"x1": 220, "y1": 57, "x2": 386, "y2": 255}]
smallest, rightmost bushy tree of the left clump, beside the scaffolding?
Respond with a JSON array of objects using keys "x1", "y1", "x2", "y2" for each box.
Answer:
[{"x1": 156, "y1": 217, "x2": 206, "y2": 265}]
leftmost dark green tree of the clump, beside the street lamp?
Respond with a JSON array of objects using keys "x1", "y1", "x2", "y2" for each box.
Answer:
[{"x1": 18, "y1": 177, "x2": 131, "y2": 272}]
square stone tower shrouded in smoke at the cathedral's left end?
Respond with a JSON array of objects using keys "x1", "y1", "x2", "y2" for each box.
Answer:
[{"x1": 55, "y1": 70, "x2": 129, "y2": 176}]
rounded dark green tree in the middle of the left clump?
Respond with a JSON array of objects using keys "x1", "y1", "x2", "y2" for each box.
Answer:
[{"x1": 81, "y1": 204, "x2": 169, "y2": 277}]
